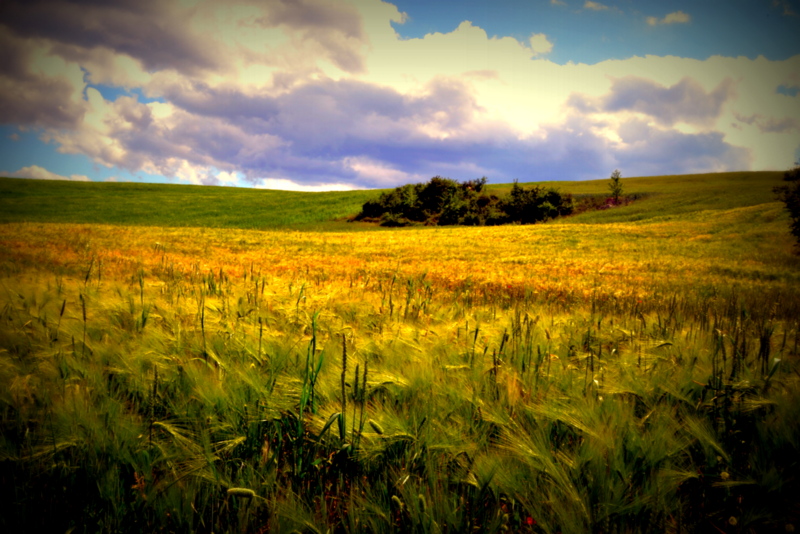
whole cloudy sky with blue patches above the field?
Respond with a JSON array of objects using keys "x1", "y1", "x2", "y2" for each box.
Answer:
[{"x1": 0, "y1": 0, "x2": 800, "y2": 191}]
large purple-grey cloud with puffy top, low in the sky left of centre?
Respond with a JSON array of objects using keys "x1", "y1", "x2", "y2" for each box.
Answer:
[{"x1": 83, "y1": 74, "x2": 506, "y2": 186}]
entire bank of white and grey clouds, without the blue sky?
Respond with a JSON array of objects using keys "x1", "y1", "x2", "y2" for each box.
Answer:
[{"x1": 0, "y1": 0, "x2": 800, "y2": 190}]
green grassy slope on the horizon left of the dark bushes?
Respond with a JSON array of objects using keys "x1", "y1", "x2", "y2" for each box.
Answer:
[{"x1": 0, "y1": 178, "x2": 374, "y2": 229}]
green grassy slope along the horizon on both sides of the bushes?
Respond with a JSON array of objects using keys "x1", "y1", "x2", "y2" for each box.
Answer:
[{"x1": 0, "y1": 172, "x2": 782, "y2": 230}]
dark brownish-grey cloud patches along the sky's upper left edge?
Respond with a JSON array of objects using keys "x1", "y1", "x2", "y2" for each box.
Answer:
[{"x1": 0, "y1": 0, "x2": 368, "y2": 76}]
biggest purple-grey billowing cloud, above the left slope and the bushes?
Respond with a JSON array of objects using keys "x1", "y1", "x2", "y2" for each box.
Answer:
[{"x1": 48, "y1": 71, "x2": 500, "y2": 186}]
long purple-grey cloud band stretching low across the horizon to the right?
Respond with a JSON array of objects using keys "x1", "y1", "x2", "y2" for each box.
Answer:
[{"x1": 69, "y1": 71, "x2": 748, "y2": 187}]
